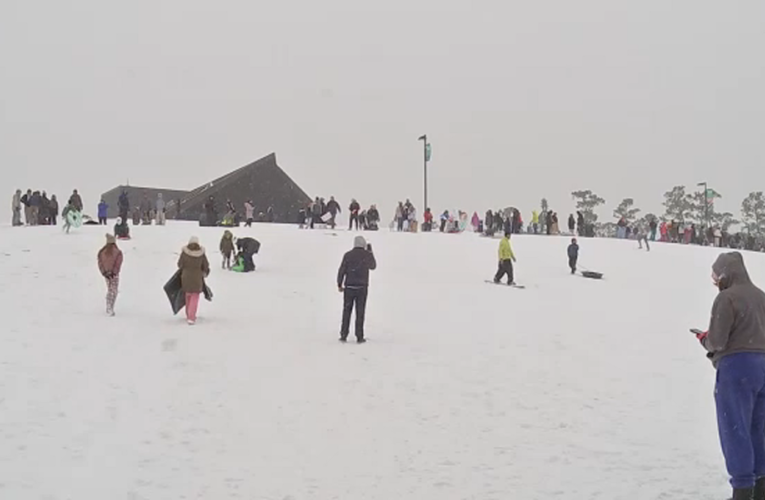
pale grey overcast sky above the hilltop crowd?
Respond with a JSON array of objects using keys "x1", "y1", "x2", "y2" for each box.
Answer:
[{"x1": 0, "y1": 0, "x2": 765, "y2": 219}]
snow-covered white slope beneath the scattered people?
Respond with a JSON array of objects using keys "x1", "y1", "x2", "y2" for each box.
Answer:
[{"x1": 0, "y1": 223, "x2": 765, "y2": 500}]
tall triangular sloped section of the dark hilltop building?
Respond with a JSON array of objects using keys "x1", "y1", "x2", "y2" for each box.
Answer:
[{"x1": 175, "y1": 153, "x2": 311, "y2": 222}]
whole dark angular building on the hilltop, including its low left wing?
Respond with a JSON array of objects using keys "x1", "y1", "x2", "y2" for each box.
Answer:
[{"x1": 103, "y1": 153, "x2": 311, "y2": 222}]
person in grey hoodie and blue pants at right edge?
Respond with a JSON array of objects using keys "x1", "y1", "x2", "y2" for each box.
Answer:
[{"x1": 695, "y1": 252, "x2": 765, "y2": 500}]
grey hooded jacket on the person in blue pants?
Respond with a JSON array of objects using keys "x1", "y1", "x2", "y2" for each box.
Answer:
[{"x1": 702, "y1": 252, "x2": 765, "y2": 366}]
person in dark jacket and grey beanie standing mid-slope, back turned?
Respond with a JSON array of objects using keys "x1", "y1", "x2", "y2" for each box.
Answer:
[{"x1": 337, "y1": 236, "x2": 377, "y2": 344}]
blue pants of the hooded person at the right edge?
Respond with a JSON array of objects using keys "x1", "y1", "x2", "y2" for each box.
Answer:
[{"x1": 715, "y1": 352, "x2": 765, "y2": 488}]
